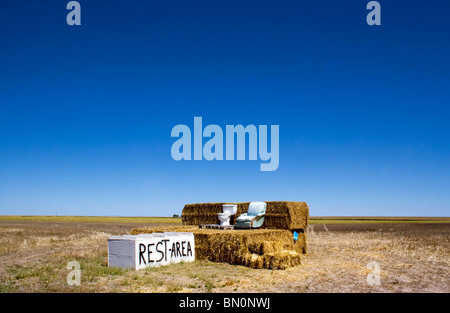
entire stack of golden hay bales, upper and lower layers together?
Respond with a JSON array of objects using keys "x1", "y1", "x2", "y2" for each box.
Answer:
[{"x1": 132, "y1": 201, "x2": 309, "y2": 269}]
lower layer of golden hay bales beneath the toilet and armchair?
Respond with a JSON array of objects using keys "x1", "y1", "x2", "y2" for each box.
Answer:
[{"x1": 131, "y1": 226, "x2": 306, "y2": 269}]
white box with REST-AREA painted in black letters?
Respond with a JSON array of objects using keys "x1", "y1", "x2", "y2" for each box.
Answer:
[{"x1": 108, "y1": 232, "x2": 195, "y2": 269}]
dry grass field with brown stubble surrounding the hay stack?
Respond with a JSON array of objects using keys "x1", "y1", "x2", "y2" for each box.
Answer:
[{"x1": 0, "y1": 217, "x2": 450, "y2": 293}]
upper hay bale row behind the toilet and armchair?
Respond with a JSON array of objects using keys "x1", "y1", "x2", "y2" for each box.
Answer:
[{"x1": 181, "y1": 201, "x2": 309, "y2": 230}]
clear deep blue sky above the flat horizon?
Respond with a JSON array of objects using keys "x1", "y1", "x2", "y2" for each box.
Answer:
[{"x1": 0, "y1": 0, "x2": 450, "y2": 216}]
